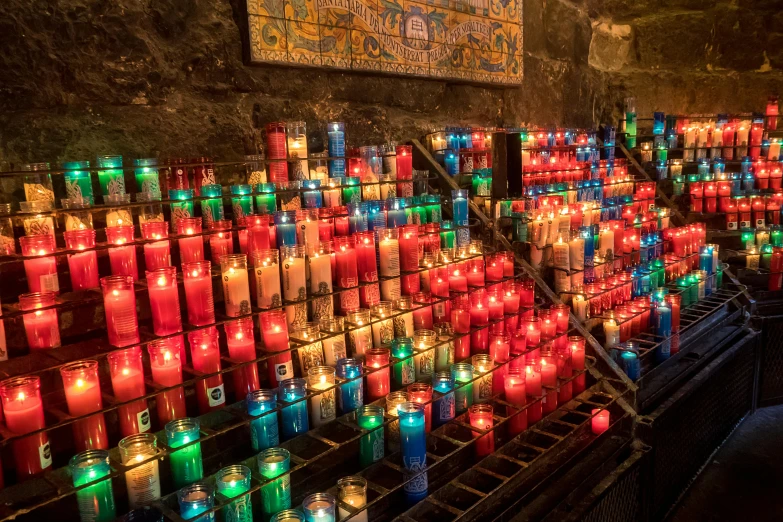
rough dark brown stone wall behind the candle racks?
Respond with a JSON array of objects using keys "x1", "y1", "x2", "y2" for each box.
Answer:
[{"x1": 0, "y1": 0, "x2": 783, "y2": 162}]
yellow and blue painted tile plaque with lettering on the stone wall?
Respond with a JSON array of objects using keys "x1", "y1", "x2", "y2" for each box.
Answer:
[{"x1": 246, "y1": 0, "x2": 522, "y2": 84}]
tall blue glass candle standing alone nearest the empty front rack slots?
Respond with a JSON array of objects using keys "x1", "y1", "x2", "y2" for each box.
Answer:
[{"x1": 397, "y1": 402, "x2": 428, "y2": 504}]
